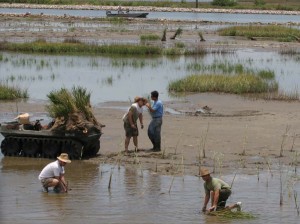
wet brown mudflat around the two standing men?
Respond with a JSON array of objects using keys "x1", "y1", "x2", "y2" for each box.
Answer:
[{"x1": 0, "y1": 94, "x2": 300, "y2": 175}]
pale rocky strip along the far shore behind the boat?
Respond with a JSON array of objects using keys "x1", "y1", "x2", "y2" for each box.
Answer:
[{"x1": 0, "y1": 3, "x2": 300, "y2": 15}]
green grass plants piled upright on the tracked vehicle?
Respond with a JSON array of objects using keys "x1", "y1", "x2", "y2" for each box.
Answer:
[{"x1": 46, "y1": 87, "x2": 92, "y2": 120}]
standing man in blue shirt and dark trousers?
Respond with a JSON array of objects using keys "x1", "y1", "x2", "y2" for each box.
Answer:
[{"x1": 146, "y1": 91, "x2": 164, "y2": 151}]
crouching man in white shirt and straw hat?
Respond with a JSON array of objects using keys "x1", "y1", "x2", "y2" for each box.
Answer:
[{"x1": 39, "y1": 153, "x2": 71, "y2": 192}]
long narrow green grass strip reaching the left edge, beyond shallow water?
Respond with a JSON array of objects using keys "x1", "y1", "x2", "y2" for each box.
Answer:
[{"x1": 0, "y1": 41, "x2": 162, "y2": 55}]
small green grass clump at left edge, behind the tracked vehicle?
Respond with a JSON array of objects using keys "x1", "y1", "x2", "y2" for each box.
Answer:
[{"x1": 0, "y1": 83, "x2": 29, "y2": 100}]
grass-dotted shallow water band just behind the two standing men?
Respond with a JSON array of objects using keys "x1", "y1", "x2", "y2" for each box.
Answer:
[{"x1": 0, "y1": 49, "x2": 300, "y2": 105}]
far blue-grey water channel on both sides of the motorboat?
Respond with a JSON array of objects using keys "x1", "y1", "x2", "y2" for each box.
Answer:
[{"x1": 0, "y1": 8, "x2": 300, "y2": 23}]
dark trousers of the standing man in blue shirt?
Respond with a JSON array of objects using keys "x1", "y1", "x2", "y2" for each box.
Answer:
[{"x1": 148, "y1": 117, "x2": 162, "y2": 150}]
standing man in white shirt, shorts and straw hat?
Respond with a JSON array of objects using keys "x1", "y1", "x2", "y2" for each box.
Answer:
[{"x1": 123, "y1": 97, "x2": 148, "y2": 153}]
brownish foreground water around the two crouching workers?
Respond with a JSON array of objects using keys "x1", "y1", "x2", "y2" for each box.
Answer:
[{"x1": 0, "y1": 156, "x2": 300, "y2": 224}]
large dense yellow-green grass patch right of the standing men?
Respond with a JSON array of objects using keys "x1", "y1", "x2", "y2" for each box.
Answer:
[{"x1": 168, "y1": 74, "x2": 278, "y2": 94}]
